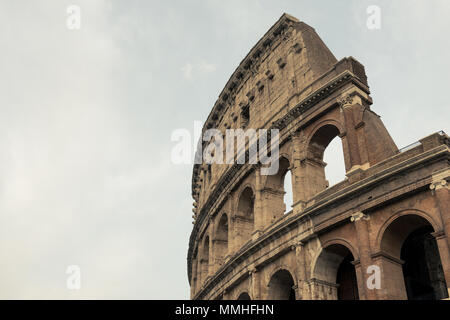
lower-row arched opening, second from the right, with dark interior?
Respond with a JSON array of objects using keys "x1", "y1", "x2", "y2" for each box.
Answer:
[{"x1": 312, "y1": 244, "x2": 359, "y2": 300}]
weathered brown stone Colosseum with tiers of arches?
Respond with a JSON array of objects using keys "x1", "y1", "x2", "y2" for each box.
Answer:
[{"x1": 187, "y1": 14, "x2": 450, "y2": 300}]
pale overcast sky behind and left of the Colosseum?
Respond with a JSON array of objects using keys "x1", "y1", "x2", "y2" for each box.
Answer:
[{"x1": 0, "y1": 0, "x2": 450, "y2": 299}]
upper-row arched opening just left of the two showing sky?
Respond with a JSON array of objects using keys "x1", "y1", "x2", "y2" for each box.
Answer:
[{"x1": 234, "y1": 187, "x2": 255, "y2": 244}]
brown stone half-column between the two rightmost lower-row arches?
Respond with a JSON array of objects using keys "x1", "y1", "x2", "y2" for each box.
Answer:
[{"x1": 351, "y1": 212, "x2": 377, "y2": 300}]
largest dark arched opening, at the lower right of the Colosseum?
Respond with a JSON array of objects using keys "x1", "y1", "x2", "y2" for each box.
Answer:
[{"x1": 381, "y1": 214, "x2": 448, "y2": 300}]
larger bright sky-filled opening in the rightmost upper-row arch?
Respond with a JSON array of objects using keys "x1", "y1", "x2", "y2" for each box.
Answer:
[{"x1": 323, "y1": 136, "x2": 345, "y2": 186}]
